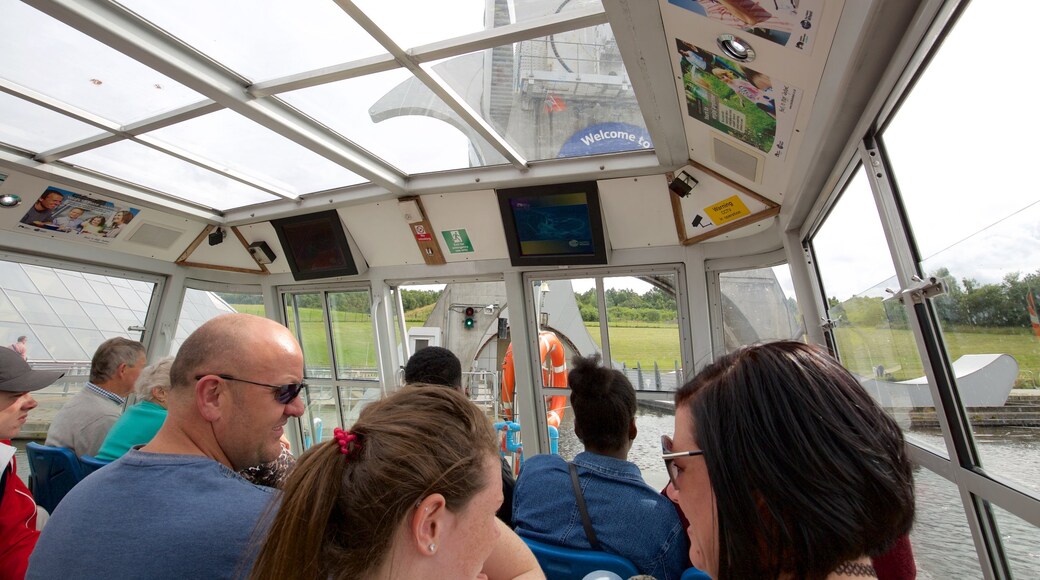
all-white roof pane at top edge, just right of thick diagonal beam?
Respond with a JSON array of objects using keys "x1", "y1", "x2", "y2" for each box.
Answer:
[{"x1": 121, "y1": 0, "x2": 386, "y2": 81}]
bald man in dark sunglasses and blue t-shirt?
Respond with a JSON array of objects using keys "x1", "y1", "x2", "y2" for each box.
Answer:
[{"x1": 27, "y1": 314, "x2": 306, "y2": 579}]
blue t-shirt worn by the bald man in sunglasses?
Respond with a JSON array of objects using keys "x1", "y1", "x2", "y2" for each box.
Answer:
[{"x1": 26, "y1": 449, "x2": 278, "y2": 580}]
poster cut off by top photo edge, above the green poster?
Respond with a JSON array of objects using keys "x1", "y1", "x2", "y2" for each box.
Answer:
[{"x1": 668, "y1": 0, "x2": 823, "y2": 54}]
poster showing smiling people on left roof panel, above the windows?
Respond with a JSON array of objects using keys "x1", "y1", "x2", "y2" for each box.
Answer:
[{"x1": 19, "y1": 186, "x2": 139, "y2": 244}]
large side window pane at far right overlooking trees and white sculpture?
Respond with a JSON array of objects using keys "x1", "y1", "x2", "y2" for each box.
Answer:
[{"x1": 883, "y1": 2, "x2": 1040, "y2": 489}]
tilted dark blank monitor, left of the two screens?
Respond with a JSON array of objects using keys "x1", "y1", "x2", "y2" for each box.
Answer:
[{"x1": 270, "y1": 210, "x2": 358, "y2": 280}]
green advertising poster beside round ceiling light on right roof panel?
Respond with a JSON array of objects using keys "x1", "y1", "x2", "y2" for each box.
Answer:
[{"x1": 675, "y1": 38, "x2": 801, "y2": 161}]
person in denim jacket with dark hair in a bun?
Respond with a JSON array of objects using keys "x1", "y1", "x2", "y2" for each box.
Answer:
[{"x1": 513, "y1": 354, "x2": 688, "y2": 579}]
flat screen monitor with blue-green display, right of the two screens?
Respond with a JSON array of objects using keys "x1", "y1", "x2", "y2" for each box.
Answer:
[{"x1": 497, "y1": 181, "x2": 607, "y2": 266}]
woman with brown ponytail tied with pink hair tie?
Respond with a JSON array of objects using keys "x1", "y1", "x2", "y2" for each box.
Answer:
[{"x1": 251, "y1": 387, "x2": 544, "y2": 580}]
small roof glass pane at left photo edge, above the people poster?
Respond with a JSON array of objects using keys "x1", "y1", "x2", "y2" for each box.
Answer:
[{"x1": 0, "y1": 91, "x2": 101, "y2": 153}]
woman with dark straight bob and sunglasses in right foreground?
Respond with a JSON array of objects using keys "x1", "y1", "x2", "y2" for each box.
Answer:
[{"x1": 661, "y1": 341, "x2": 914, "y2": 580}]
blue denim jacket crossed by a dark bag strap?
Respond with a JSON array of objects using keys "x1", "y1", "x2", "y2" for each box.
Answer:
[{"x1": 513, "y1": 451, "x2": 690, "y2": 580}]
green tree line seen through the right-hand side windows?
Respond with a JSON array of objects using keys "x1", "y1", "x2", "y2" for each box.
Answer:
[{"x1": 828, "y1": 267, "x2": 1040, "y2": 328}]
